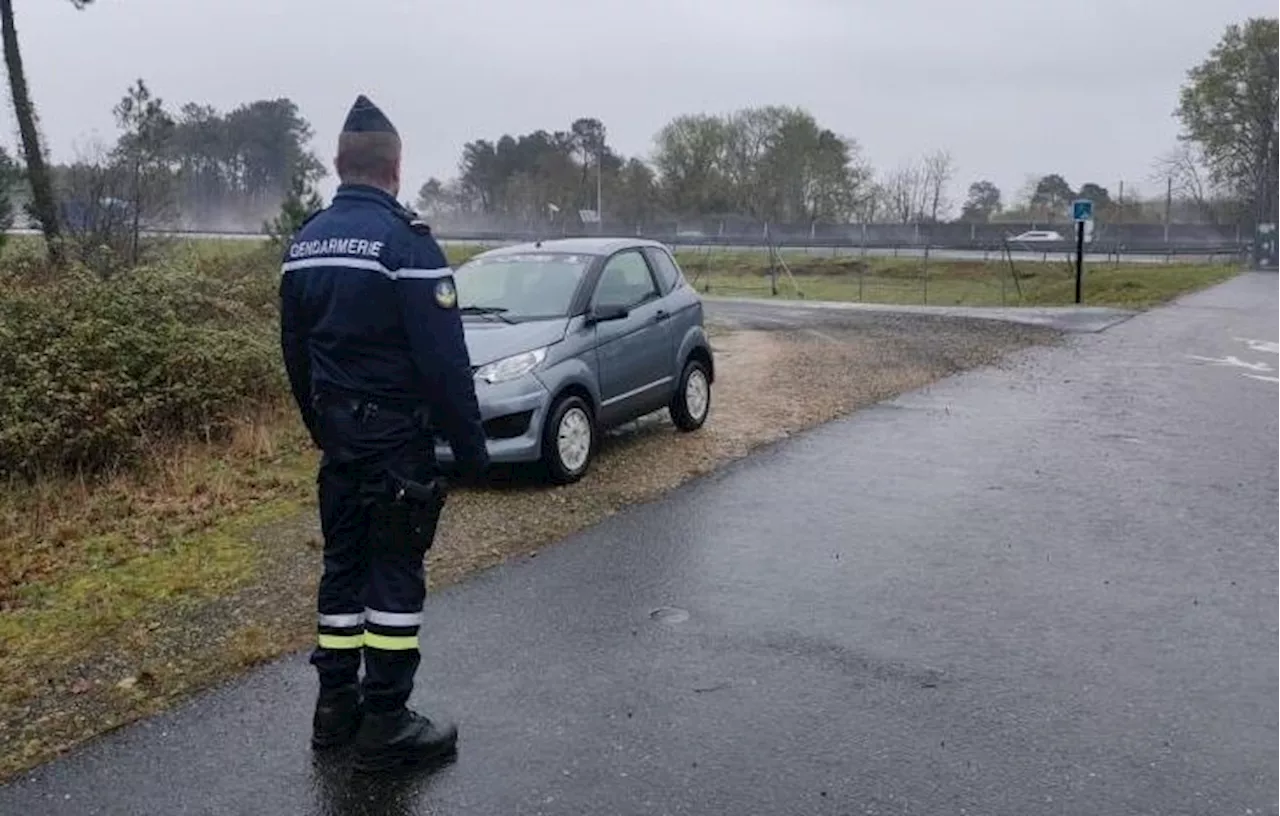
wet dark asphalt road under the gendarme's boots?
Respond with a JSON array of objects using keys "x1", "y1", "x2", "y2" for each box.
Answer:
[{"x1": 0, "y1": 275, "x2": 1280, "y2": 816}]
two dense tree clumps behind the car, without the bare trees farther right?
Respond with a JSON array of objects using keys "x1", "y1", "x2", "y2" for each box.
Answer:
[{"x1": 416, "y1": 106, "x2": 890, "y2": 225}]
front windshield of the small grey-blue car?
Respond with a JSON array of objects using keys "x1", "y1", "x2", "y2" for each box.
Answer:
[{"x1": 454, "y1": 252, "x2": 591, "y2": 320}]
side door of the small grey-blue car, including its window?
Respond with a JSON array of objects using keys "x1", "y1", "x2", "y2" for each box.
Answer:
[{"x1": 591, "y1": 249, "x2": 676, "y2": 425}]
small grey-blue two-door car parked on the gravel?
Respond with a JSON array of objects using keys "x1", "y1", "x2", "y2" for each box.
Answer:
[{"x1": 436, "y1": 238, "x2": 716, "y2": 485}]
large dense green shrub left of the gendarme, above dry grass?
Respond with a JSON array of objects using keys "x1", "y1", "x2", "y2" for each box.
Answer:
[{"x1": 0, "y1": 253, "x2": 287, "y2": 477}]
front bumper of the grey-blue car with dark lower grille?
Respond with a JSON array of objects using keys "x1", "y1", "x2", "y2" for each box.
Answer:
[{"x1": 435, "y1": 373, "x2": 550, "y2": 464}]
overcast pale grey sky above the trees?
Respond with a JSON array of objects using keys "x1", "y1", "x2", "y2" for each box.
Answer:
[{"x1": 6, "y1": 0, "x2": 1277, "y2": 204}]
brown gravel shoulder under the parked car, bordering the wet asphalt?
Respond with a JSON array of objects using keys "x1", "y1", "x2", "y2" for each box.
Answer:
[{"x1": 0, "y1": 313, "x2": 1061, "y2": 780}]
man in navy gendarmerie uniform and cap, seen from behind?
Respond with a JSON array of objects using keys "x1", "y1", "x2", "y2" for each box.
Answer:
[{"x1": 280, "y1": 96, "x2": 488, "y2": 769}]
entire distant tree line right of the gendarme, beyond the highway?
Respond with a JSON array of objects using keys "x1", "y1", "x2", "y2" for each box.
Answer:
[{"x1": 415, "y1": 106, "x2": 1248, "y2": 229}]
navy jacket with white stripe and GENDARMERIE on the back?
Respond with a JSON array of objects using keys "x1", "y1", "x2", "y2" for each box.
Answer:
[{"x1": 280, "y1": 185, "x2": 488, "y2": 469}]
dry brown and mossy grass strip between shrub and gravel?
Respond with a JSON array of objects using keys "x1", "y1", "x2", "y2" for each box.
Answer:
[{"x1": 0, "y1": 407, "x2": 314, "y2": 721}]
